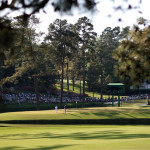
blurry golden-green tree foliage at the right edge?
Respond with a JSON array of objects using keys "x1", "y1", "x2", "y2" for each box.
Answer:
[{"x1": 114, "y1": 18, "x2": 150, "y2": 85}]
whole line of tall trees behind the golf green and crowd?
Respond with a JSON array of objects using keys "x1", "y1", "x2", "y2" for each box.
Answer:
[{"x1": 0, "y1": 15, "x2": 149, "y2": 109}]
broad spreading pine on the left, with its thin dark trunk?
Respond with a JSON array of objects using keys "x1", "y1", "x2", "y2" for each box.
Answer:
[{"x1": 1, "y1": 16, "x2": 56, "y2": 109}]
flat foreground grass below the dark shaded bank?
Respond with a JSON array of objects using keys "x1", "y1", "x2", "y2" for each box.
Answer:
[{"x1": 0, "y1": 124, "x2": 150, "y2": 150}]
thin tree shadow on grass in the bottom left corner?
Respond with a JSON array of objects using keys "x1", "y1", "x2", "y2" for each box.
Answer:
[{"x1": 0, "y1": 145, "x2": 73, "y2": 150}]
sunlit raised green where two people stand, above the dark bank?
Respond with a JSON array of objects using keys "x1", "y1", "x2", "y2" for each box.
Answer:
[{"x1": 0, "y1": 100, "x2": 150, "y2": 121}]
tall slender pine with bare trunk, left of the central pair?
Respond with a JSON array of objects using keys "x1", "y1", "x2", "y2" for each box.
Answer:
[{"x1": 45, "y1": 19, "x2": 77, "y2": 106}]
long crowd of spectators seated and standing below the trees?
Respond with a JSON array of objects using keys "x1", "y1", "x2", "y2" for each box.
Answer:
[{"x1": 0, "y1": 92, "x2": 149, "y2": 104}]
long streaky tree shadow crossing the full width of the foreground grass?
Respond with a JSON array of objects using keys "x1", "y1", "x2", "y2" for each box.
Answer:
[{"x1": 0, "y1": 130, "x2": 150, "y2": 140}]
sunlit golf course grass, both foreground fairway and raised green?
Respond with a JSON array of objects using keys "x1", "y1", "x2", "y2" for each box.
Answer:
[{"x1": 0, "y1": 100, "x2": 150, "y2": 150}]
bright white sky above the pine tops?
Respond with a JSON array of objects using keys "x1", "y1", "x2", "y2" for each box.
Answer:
[{"x1": 34, "y1": 0, "x2": 150, "y2": 35}]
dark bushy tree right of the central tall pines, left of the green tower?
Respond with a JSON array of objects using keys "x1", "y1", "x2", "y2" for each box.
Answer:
[{"x1": 88, "y1": 27, "x2": 120, "y2": 99}]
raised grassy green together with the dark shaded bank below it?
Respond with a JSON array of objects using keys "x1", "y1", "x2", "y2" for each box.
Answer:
[{"x1": 0, "y1": 100, "x2": 150, "y2": 125}]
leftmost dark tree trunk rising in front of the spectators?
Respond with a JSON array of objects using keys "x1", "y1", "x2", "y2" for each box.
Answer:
[{"x1": 34, "y1": 76, "x2": 40, "y2": 110}]
